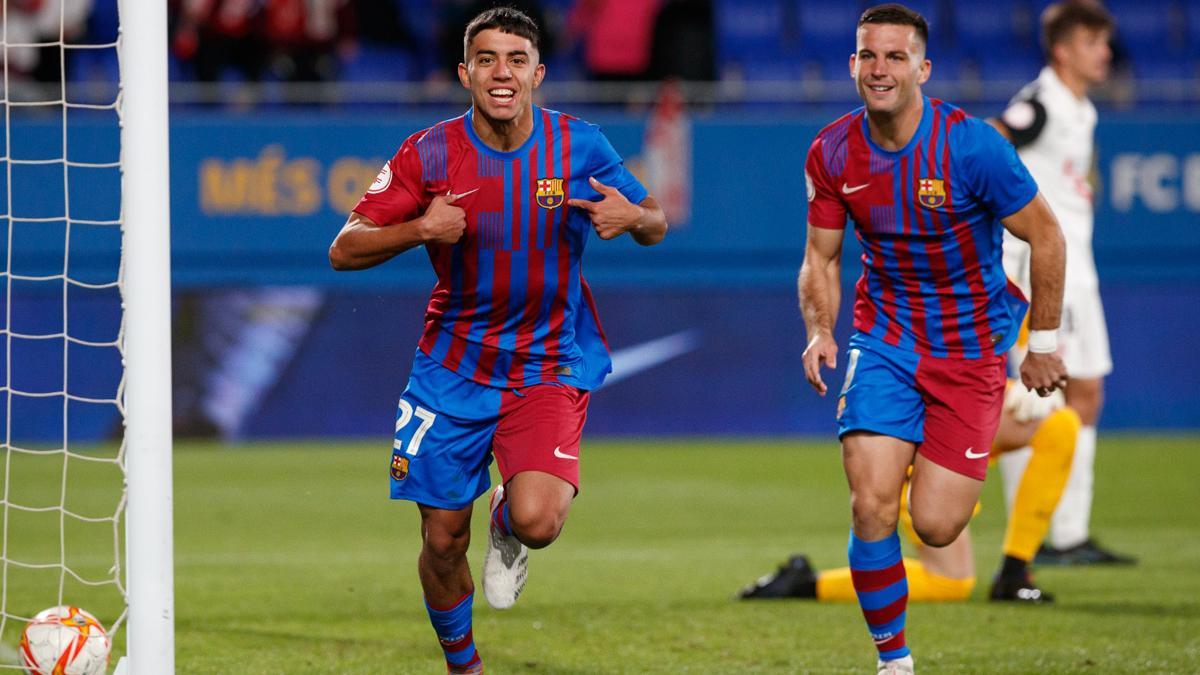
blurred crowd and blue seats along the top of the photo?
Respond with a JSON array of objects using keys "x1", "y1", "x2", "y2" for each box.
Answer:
[{"x1": 0, "y1": 0, "x2": 1200, "y2": 93}]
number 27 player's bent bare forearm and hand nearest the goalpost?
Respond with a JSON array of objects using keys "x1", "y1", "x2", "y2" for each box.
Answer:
[{"x1": 329, "y1": 195, "x2": 467, "y2": 271}]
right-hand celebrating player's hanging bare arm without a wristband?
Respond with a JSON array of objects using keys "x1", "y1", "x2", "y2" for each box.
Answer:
[{"x1": 797, "y1": 225, "x2": 842, "y2": 396}]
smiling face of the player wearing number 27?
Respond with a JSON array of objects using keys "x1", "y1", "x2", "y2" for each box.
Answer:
[{"x1": 458, "y1": 29, "x2": 546, "y2": 123}]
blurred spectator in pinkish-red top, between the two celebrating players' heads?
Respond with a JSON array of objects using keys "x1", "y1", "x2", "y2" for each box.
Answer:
[{"x1": 568, "y1": 0, "x2": 660, "y2": 80}]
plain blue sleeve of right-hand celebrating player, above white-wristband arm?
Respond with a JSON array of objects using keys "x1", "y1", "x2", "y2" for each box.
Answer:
[{"x1": 960, "y1": 118, "x2": 1038, "y2": 219}]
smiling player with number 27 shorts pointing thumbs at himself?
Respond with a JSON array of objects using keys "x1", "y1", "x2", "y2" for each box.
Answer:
[{"x1": 329, "y1": 7, "x2": 667, "y2": 673}]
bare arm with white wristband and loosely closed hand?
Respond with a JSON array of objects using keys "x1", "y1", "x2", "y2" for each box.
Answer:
[{"x1": 1001, "y1": 193, "x2": 1067, "y2": 396}]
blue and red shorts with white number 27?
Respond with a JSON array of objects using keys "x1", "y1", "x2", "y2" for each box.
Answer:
[{"x1": 390, "y1": 350, "x2": 588, "y2": 510}]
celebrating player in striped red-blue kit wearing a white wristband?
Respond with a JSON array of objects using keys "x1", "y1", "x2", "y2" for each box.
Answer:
[{"x1": 799, "y1": 4, "x2": 1067, "y2": 673}]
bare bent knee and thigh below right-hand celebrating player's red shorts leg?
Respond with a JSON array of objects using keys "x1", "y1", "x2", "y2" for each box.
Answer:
[{"x1": 908, "y1": 454, "x2": 983, "y2": 548}]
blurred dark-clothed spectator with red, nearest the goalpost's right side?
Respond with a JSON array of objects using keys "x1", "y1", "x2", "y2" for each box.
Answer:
[{"x1": 172, "y1": 0, "x2": 266, "y2": 82}]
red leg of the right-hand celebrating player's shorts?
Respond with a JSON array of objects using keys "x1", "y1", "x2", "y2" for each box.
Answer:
[{"x1": 917, "y1": 356, "x2": 1006, "y2": 480}]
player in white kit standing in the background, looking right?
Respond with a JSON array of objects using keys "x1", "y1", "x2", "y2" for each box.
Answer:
[{"x1": 991, "y1": 0, "x2": 1134, "y2": 565}]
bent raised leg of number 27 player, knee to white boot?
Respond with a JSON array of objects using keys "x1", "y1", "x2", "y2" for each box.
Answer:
[{"x1": 484, "y1": 471, "x2": 575, "y2": 609}]
